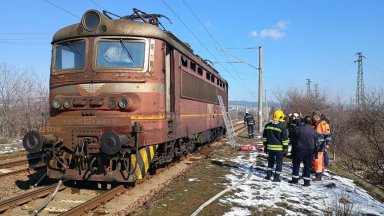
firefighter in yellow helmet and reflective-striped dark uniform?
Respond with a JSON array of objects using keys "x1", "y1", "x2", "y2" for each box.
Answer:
[{"x1": 263, "y1": 110, "x2": 288, "y2": 182}]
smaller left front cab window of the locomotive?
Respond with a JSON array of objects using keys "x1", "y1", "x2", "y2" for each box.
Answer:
[{"x1": 53, "y1": 40, "x2": 86, "y2": 71}]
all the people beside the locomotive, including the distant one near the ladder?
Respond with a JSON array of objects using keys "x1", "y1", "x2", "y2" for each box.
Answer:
[{"x1": 248, "y1": 110, "x2": 332, "y2": 186}]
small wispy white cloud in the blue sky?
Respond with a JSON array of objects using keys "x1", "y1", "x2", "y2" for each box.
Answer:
[{"x1": 250, "y1": 20, "x2": 291, "y2": 40}]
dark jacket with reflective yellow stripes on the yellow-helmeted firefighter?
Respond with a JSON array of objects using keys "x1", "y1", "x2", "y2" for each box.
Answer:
[{"x1": 263, "y1": 121, "x2": 288, "y2": 151}]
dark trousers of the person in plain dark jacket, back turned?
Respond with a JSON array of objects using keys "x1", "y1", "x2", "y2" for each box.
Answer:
[{"x1": 292, "y1": 149, "x2": 313, "y2": 180}]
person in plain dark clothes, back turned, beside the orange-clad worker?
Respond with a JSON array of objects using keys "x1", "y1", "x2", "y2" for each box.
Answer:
[{"x1": 288, "y1": 116, "x2": 317, "y2": 186}]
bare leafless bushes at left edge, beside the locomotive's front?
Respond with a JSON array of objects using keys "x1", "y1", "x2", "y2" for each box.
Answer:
[{"x1": 0, "y1": 63, "x2": 48, "y2": 138}]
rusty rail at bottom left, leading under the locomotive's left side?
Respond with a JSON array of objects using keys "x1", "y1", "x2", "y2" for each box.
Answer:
[{"x1": 0, "y1": 184, "x2": 66, "y2": 214}]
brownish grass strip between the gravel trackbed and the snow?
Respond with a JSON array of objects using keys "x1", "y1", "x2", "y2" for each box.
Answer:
[{"x1": 130, "y1": 147, "x2": 234, "y2": 216}]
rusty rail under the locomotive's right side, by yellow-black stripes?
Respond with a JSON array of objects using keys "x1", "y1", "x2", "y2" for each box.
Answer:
[{"x1": 61, "y1": 185, "x2": 128, "y2": 216}]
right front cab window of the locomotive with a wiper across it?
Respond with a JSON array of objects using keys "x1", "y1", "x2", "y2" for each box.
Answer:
[{"x1": 96, "y1": 39, "x2": 145, "y2": 68}]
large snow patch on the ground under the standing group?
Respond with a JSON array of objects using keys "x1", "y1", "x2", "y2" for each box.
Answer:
[{"x1": 220, "y1": 153, "x2": 384, "y2": 216}]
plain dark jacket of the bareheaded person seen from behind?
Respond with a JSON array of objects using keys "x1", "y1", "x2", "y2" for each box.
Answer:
[{"x1": 294, "y1": 125, "x2": 318, "y2": 150}]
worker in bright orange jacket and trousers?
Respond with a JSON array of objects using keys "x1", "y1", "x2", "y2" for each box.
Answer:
[{"x1": 312, "y1": 112, "x2": 332, "y2": 181}]
